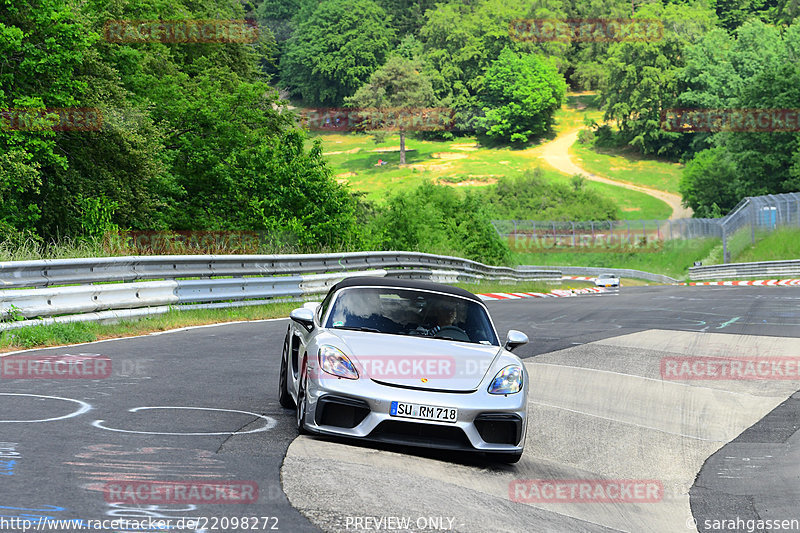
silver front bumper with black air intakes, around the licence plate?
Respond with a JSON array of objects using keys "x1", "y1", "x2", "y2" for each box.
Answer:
[{"x1": 306, "y1": 377, "x2": 527, "y2": 453}]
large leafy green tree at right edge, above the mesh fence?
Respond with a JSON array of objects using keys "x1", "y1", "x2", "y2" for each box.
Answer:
[{"x1": 679, "y1": 21, "x2": 800, "y2": 216}]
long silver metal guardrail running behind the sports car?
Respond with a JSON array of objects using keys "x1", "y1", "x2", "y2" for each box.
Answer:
[{"x1": 0, "y1": 252, "x2": 561, "y2": 330}]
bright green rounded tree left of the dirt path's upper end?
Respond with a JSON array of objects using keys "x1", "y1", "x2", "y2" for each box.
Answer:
[{"x1": 478, "y1": 48, "x2": 567, "y2": 144}]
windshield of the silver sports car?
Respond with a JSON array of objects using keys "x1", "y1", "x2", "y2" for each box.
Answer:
[{"x1": 325, "y1": 287, "x2": 499, "y2": 346}]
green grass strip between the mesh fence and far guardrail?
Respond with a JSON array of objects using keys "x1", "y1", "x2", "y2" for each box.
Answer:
[{"x1": 512, "y1": 239, "x2": 720, "y2": 279}]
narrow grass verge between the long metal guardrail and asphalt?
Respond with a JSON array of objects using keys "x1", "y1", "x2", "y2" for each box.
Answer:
[{"x1": 0, "y1": 281, "x2": 592, "y2": 353}]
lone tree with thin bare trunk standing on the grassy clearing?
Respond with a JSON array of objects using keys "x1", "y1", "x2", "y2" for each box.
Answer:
[{"x1": 346, "y1": 56, "x2": 434, "y2": 165}]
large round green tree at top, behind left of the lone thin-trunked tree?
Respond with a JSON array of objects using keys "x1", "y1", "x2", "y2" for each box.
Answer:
[{"x1": 281, "y1": 0, "x2": 395, "y2": 106}]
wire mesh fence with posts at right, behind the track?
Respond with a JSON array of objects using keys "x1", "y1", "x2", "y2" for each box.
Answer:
[{"x1": 492, "y1": 193, "x2": 800, "y2": 263}]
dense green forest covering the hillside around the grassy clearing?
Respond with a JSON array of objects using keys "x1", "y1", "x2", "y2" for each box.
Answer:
[{"x1": 0, "y1": 0, "x2": 800, "y2": 261}]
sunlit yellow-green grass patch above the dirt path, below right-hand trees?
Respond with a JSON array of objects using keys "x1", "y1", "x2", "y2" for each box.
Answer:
[{"x1": 570, "y1": 142, "x2": 683, "y2": 194}]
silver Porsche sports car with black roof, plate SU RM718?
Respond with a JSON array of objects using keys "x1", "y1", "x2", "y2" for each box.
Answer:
[{"x1": 279, "y1": 277, "x2": 528, "y2": 463}]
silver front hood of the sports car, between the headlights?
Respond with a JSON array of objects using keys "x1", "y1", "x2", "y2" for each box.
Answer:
[{"x1": 328, "y1": 330, "x2": 503, "y2": 391}]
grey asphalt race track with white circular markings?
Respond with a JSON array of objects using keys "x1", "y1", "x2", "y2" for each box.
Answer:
[{"x1": 0, "y1": 286, "x2": 800, "y2": 532}]
